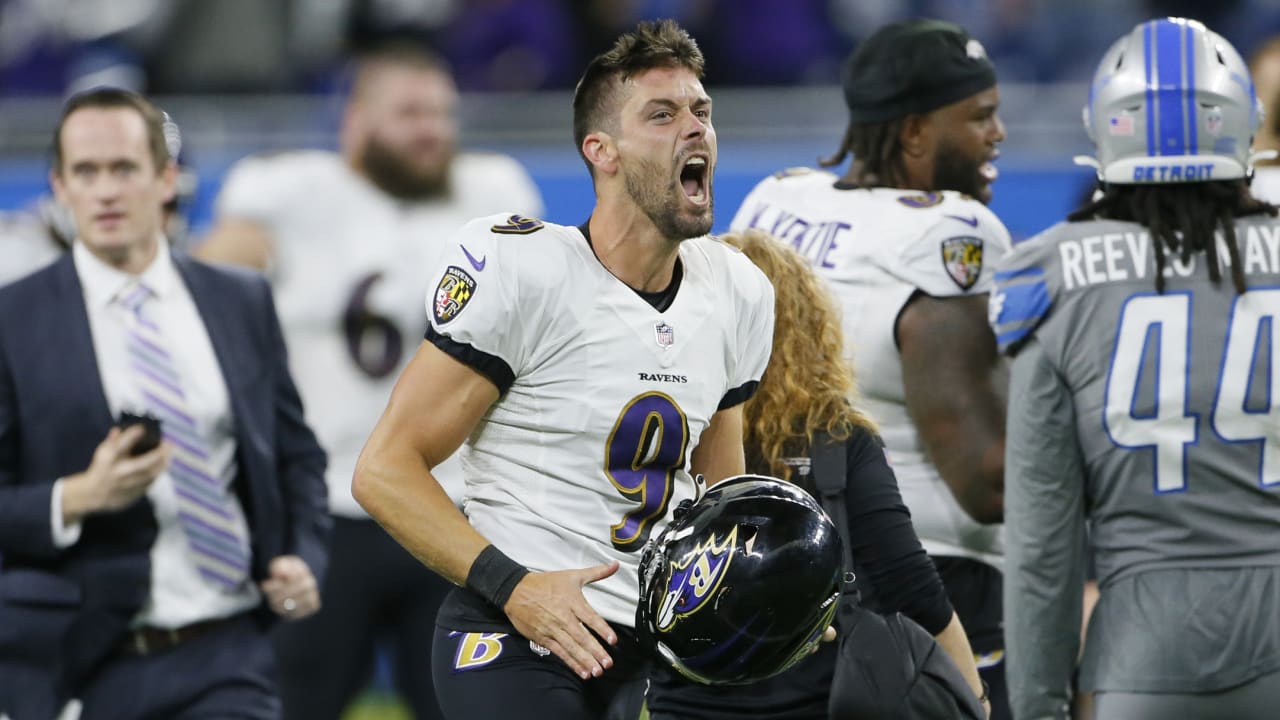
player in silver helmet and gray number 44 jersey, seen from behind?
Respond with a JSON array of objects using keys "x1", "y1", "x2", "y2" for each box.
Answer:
[{"x1": 991, "y1": 18, "x2": 1280, "y2": 720}]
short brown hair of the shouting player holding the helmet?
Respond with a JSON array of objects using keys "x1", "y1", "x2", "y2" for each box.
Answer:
[{"x1": 573, "y1": 19, "x2": 704, "y2": 173}]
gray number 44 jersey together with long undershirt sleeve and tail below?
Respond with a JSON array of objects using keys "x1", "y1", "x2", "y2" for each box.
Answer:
[{"x1": 989, "y1": 218, "x2": 1280, "y2": 717}]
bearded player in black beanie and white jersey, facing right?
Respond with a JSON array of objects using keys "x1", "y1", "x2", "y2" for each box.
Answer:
[{"x1": 731, "y1": 20, "x2": 1010, "y2": 717}]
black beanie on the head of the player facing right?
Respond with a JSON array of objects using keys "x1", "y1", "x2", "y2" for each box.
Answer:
[{"x1": 842, "y1": 19, "x2": 996, "y2": 124}]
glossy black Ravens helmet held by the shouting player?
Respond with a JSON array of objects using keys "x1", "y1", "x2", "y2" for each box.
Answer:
[{"x1": 636, "y1": 475, "x2": 844, "y2": 685}]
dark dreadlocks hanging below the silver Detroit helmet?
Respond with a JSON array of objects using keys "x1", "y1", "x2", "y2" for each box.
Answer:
[{"x1": 1066, "y1": 179, "x2": 1276, "y2": 293}]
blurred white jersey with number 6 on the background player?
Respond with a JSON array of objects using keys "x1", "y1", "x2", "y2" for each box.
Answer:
[{"x1": 216, "y1": 151, "x2": 541, "y2": 518}]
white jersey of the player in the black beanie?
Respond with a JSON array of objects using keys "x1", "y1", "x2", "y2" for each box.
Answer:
[{"x1": 731, "y1": 169, "x2": 1011, "y2": 566}]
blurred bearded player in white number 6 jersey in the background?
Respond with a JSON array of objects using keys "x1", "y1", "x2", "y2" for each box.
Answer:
[{"x1": 200, "y1": 45, "x2": 541, "y2": 720}]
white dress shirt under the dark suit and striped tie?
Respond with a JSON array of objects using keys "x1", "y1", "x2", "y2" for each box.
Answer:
[{"x1": 52, "y1": 238, "x2": 261, "y2": 628}]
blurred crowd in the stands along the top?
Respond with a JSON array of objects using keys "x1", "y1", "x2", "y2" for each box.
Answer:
[{"x1": 0, "y1": 0, "x2": 1280, "y2": 96}]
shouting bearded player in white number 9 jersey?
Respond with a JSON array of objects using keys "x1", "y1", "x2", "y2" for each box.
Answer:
[{"x1": 352, "y1": 20, "x2": 773, "y2": 720}]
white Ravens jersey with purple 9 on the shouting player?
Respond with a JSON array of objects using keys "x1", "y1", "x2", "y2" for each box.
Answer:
[{"x1": 426, "y1": 215, "x2": 773, "y2": 626}]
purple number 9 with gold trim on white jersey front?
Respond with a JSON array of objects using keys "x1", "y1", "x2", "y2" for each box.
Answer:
[{"x1": 604, "y1": 392, "x2": 689, "y2": 552}]
